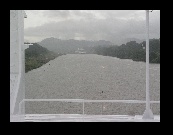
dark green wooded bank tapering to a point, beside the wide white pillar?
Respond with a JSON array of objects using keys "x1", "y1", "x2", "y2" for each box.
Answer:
[{"x1": 25, "y1": 43, "x2": 62, "y2": 72}]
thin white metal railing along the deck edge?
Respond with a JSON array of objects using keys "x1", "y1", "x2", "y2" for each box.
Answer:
[{"x1": 19, "y1": 99, "x2": 160, "y2": 115}]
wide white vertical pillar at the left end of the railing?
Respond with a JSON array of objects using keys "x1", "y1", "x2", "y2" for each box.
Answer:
[{"x1": 10, "y1": 10, "x2": 25, "y2": 122}]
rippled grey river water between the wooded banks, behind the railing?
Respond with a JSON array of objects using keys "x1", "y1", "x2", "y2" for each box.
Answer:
[{"x1": 25, "y1": 54, "x2": 160, "y2": 115}]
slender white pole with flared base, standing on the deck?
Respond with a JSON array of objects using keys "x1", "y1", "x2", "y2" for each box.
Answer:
[{"x1": 143, "y1": 10, "x2": 154, "y2": 119}]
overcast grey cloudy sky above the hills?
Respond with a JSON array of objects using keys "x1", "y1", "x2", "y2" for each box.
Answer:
[{"x1": 24, "y1": 10, "x2": 160, "y2": 44}]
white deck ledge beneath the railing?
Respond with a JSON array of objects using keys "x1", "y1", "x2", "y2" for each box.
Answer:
[{"x1": 10, "y1": 114, "x2": 160, "y2": 122}]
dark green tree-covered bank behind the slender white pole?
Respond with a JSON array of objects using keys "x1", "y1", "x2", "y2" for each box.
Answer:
[{"x1": 95, "y1": 39, "x2": 160, "y2": 63}]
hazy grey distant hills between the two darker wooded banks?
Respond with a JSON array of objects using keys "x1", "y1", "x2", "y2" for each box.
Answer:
[{"x1": 38, "y1": 37, "x2": 113, "y2": 54}]
